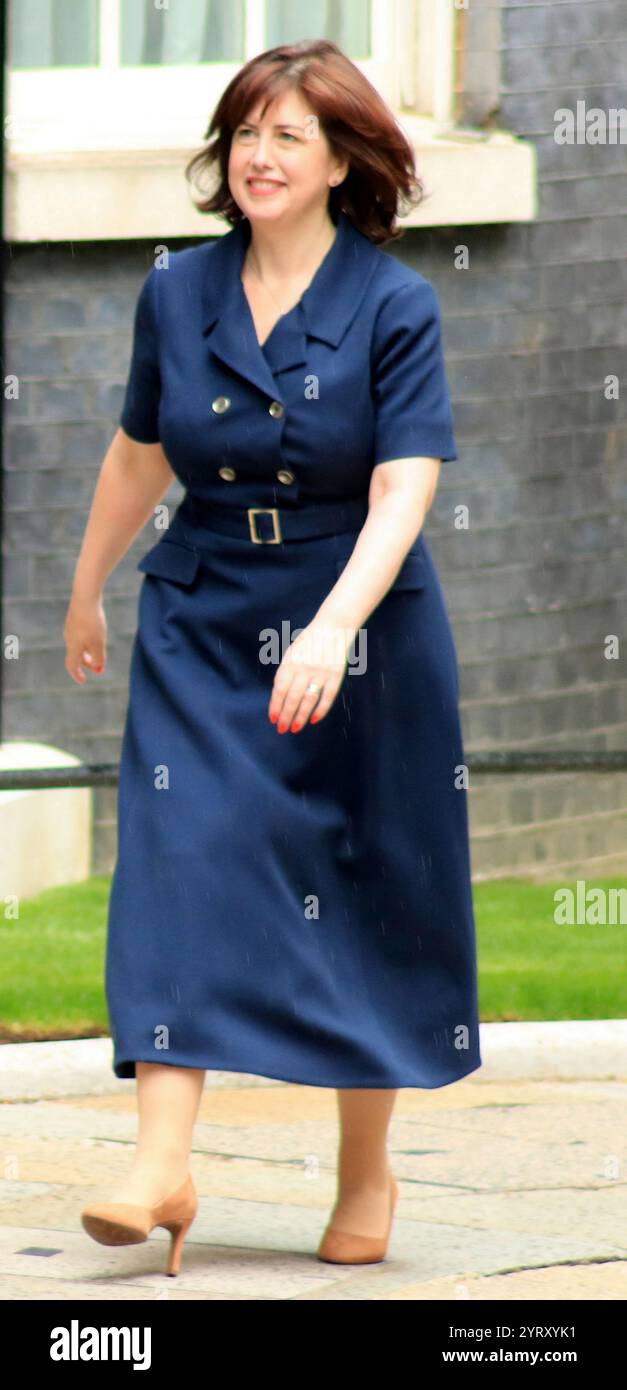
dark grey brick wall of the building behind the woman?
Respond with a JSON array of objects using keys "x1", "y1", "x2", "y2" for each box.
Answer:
[{"x1": 3, "y1": 0, "x2": 627, "y2": 877}]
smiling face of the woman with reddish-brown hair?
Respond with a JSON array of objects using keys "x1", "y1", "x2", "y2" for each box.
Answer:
[{"x1": 228, "y1": 90, "x2": 348, "y2": 222}]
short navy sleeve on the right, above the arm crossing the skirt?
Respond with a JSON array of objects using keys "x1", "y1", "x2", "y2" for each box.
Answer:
[{"x1": 373, "y1": 278, "x2": 457, "y2": 464}]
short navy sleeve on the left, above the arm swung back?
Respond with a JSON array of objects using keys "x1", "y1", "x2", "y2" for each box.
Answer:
[{"x1": 120, "y1": 265, "x2": 161, "y2": 443}]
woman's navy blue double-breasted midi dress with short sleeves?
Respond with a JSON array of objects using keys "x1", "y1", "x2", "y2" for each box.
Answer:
[{"x1": 106, "y1": 213, "x2": 481, "y2": 1087}]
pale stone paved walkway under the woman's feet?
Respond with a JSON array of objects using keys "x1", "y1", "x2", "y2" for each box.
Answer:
[{"x1": 0, "y1": 1067, "x2": 627, "y2": 1302}]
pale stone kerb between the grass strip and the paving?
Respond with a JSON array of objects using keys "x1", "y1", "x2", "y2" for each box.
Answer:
[{"x1": 0, "y1": 1019, "x2": 627, "y2": 1101}]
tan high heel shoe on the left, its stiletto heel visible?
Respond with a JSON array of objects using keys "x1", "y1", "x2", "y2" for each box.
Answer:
[{"x1": 81, "y1": 1173, "x2": 197, "y2": 1275}]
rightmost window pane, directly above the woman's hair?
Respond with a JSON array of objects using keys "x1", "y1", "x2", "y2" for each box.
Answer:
[{"x1": 266, "y1": 0, "x2": 370, "y2": 58}]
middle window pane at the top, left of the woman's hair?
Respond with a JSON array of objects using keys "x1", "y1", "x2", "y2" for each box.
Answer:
[{"x1": 121, "y1": 0, "x2": 245, "y2": 65}]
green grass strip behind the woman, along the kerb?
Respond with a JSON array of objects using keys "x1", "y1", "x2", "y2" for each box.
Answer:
[{"x1": 0, "y1": 876, "x2": 627, "y2": 1041}]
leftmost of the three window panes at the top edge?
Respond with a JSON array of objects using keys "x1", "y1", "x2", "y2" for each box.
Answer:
[{"x1": 8, "y1": 0, "x2": 99, "y2": 68}]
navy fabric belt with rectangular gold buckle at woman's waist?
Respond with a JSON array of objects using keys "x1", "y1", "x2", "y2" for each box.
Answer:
[{"x1": 182, "y1": 493, "x2": 368, "y2": 545}]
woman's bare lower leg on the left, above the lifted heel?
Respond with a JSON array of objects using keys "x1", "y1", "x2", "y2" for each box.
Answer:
[{"x1": 108, "y1": 1062, "x2": 204, "y2": 1207}]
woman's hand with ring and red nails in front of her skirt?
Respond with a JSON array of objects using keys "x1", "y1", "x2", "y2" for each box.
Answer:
[{"x1": 268, "y1": 619, "x2": 355, "y2": 734}]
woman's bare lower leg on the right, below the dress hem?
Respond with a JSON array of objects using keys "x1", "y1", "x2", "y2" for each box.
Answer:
[{"x1": 331, "y1": 1090, "x2": 398, "y2": 1236}]
